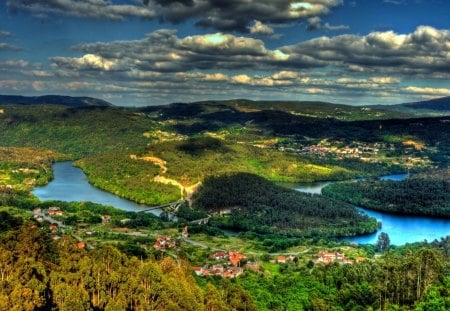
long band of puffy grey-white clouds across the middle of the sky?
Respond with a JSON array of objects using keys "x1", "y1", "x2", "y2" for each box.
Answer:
[{"x1": 47, "y1": 26, "x2": 450, "y2": 84}]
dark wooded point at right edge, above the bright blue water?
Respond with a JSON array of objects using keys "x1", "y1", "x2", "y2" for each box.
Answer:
[{"x1": 323, "y1": 170, "x2": 450, "y2": 218}]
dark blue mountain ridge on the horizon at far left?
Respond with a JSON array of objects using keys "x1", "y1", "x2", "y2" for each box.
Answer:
[{"x1": 0, "y1": 95, "x2": 112, "y2": 108}]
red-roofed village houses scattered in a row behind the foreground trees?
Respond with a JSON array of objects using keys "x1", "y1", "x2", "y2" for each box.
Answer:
[{"x1": 33, "y1": 206, "x2": 366, "y2": 279}]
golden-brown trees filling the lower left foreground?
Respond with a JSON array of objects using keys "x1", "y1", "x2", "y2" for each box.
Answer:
[{"x1": 0, "y1": 222, "x2": 255, "y2": 311}]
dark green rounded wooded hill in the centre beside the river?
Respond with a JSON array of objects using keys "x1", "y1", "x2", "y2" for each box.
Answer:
[{"x1": 194, "y1": 174, "x2": 377, "y2": 236}]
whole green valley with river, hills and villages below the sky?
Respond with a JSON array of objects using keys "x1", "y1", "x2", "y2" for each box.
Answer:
[{"x1": 0, "y1": 100, "x2": 450, "y2": 310}]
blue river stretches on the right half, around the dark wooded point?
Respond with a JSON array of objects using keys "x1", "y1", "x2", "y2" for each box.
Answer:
[{"x1": 289, "y1": 174, "x2": 450, "y2": 245}]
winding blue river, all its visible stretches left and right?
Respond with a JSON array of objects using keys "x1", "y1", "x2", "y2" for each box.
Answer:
[{"x1": 33, "y1": 162, "x2": 450, "y2": 245}]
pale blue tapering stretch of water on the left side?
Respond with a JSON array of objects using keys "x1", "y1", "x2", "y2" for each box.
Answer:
[{"x1": 33, "y1": 162, "x2": 161, "y2": 215}]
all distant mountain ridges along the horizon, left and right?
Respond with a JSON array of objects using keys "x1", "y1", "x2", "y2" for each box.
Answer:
[{"x1": 0, "y1": 95, "x2": 450, "y2": 120}]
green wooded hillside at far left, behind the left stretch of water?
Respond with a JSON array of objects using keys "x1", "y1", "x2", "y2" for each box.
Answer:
[{"x1": 0, "y1": 105, "x2": 150, "y2": 158}]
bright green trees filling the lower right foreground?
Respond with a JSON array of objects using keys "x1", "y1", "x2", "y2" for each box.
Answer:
[{"x1": 234, "y1": 246, "x2": 450, "y2": 311}]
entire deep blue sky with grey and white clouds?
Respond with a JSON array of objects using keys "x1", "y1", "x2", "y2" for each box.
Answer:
[{"x1": 0, "y1": 0, "x2": 450, "y2": 106}]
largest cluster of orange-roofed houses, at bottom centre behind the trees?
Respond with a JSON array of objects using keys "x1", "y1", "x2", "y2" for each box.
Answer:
[{"x1": 193, "y1": 251, "x2": 248, "y2": 279}]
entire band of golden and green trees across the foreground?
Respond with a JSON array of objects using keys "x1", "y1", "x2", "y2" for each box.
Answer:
[{"x1": 0, "y1": 213, "x2": 450, "y2": 311}]
